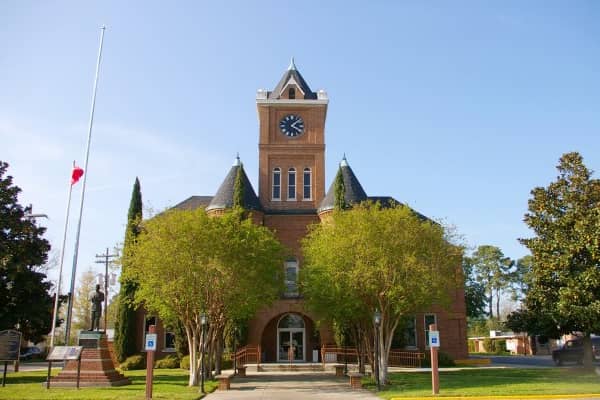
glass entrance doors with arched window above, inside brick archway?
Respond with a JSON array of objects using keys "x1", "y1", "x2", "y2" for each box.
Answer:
[{"x1": 277, "y1": 314, "x2": 306, "y2": 362}]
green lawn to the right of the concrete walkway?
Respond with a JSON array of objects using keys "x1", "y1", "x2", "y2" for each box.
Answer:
[{"x1": 364, "y1": 368, "x2": 600, "y2": 399}]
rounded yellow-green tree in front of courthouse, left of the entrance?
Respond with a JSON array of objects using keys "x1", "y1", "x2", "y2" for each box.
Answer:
[{"x1": 124, "y1": 210, "x2": 283, "y2": 386}]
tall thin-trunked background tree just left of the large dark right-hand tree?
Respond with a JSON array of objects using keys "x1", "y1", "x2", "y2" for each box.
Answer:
[{"x1": 470, "y1": 245, "x2": 513, "y2": 318}]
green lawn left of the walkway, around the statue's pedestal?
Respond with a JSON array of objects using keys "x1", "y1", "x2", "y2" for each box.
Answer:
[{"x1": 0, "y1": 369, "x2": 217, "y2": 400}]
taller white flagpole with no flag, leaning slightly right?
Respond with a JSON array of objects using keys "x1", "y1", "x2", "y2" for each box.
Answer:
[{"x1": 65, "y1": 26, "x2": 106, "y2": 345}]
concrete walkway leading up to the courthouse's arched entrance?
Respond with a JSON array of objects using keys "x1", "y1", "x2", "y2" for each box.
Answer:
[{"x1": 205, "y1": 372, "x2": 379, "y2": 400}]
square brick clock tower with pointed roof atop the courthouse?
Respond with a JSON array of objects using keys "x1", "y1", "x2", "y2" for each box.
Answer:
[{"x1": 256, "y1": 59, "x2": 328, "y2": 214}]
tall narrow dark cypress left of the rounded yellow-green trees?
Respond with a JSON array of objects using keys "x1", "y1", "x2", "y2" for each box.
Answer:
[{"x1": 115, "y1": 177, "x2": 142, "y2": 362}]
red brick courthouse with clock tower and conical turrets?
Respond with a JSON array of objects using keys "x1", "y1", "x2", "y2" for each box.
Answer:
[{"x1": 138, "y1": 61, "x2": 467, "y2": 362}]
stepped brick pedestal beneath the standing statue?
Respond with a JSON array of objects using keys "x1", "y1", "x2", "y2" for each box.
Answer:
[{"x1": 50, "y1": 331, "x2": 131, "y2": 387}]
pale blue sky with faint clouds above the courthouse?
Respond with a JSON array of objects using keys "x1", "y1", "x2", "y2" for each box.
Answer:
[{"x1": 0, "y1": 0, "x2": 600, "y2": 285}]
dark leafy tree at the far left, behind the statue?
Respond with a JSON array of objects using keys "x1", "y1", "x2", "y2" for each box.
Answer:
[{"x1": 0, "y1": 161, "x2": 53, "y2": 343}]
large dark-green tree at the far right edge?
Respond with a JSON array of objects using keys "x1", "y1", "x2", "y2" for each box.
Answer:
[{"x1": 520, "y1": 152, "x2": 600, "y2": 368}]
